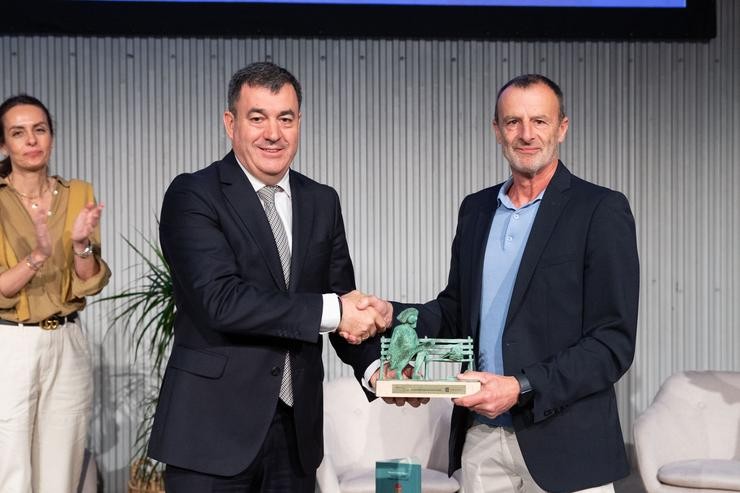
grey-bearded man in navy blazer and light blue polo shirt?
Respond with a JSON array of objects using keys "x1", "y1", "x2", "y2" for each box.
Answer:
[{"x1": 368, "y1": 75, "x2": 639, "y2": 493}]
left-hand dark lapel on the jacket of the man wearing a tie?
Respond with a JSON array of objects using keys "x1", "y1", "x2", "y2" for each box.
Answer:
[{"x1": 219, "y1": 151, "x2": 286, "y2": 289}]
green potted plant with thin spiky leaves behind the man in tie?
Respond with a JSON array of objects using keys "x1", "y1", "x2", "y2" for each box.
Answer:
[{"x1": 98, "y1": 238, "x2": 175, "y2": 493}]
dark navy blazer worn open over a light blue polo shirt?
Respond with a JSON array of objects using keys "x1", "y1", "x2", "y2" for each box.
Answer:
[{"x1": 394, "y1": 163, "x2": 639, "y2": 492}]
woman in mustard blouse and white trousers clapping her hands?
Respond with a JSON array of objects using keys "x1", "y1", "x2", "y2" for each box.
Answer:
[{"x1": 0, "y1": 95, "x2": 110, "y2": 493}]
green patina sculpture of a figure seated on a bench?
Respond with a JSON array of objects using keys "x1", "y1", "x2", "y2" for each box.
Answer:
[{"x1": 380, "y1": 308, "x2": 475, "y2": 380}]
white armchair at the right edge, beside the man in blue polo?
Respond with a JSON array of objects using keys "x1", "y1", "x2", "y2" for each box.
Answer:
[{"x1": 634, "y1": 371, "x2": 740, "y2": 493}]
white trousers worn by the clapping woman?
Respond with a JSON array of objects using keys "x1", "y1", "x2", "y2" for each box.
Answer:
[{"x1": 0, "y1": 322, "x2": 93, "y2": 493}]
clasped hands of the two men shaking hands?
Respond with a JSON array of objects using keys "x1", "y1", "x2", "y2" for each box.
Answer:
[{"x1": 337, "y1": 290, "x2": 393, "y2": 344}]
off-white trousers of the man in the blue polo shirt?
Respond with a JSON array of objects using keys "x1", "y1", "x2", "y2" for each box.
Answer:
[{"x1": 460, "y1": 424, "x2": 614, "y2": 493}]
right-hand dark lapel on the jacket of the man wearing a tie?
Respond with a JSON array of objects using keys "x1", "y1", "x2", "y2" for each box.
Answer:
[{"x1": 290, "y1": 171, "x2": 315, "y2": 291}]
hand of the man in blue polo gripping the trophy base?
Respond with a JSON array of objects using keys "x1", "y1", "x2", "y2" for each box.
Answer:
[{"x1": 452, "y1": 371, "x2": 521, "y2": 419}]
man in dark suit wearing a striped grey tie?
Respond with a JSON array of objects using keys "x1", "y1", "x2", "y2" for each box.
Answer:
[{"x1": 149, "y1": 63, "x2": 390, "y2": 493}]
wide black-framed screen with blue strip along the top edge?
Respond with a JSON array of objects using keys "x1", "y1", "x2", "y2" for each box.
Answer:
[{"x1": 11, "y1": 0, "x2": 717, "y2": 40}]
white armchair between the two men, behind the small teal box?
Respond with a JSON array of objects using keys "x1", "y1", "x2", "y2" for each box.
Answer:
[{"x1": 316, "y1": 377, "x2": 460, "y2": 493}]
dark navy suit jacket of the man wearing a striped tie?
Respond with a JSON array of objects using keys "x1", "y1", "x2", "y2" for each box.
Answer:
[{"x1": 149, "y1": 152, "x2": 377, "y2": 476}]
